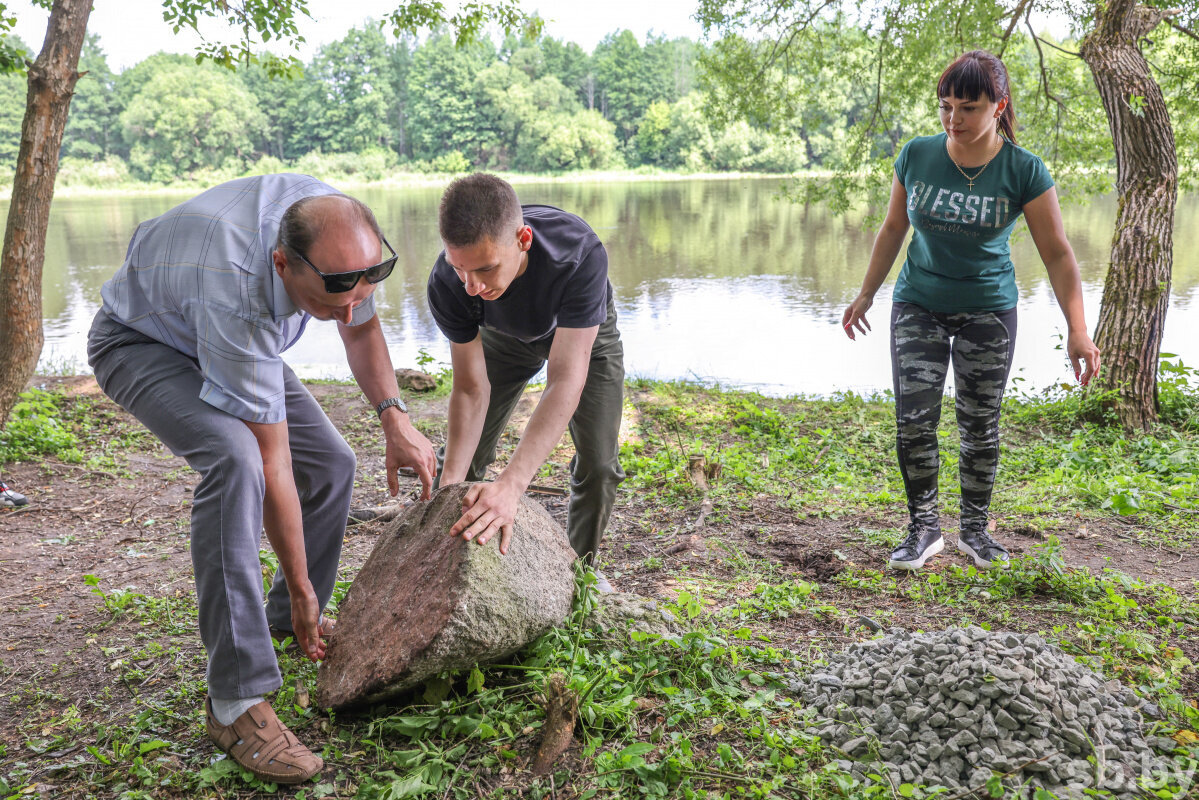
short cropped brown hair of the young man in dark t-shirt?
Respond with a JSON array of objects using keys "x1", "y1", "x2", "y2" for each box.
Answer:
[{"x1": 438, "y1": 173, "x2": 524, "y2": 247}]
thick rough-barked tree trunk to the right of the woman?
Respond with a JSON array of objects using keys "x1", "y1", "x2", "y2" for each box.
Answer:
[{"x1": 1080, "y1": 0, "x2": 1179, "y2": 429}]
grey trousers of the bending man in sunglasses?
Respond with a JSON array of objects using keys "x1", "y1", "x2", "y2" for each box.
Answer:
[{"x1": 88, "y1": 312, "x2": 356, "y2": 699}]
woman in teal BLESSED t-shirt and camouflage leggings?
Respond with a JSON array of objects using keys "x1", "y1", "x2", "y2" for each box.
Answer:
[{"x1": 842, "y1": 50, "x2": 1099, "y2": 570}]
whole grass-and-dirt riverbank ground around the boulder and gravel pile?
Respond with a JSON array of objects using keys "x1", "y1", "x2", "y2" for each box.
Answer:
[{"x1": 0, "y1": 377, "x2": 1199, "y2": 798}]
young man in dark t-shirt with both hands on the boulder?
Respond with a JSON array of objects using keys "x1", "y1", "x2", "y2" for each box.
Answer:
[{"x1": 428, "y1": 173, "x2": 625, "y2": 589}]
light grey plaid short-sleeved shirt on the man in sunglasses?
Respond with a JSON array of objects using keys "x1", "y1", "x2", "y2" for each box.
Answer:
[{"x1": 101, "y1": 174, "x2": 375, "y2": 422}]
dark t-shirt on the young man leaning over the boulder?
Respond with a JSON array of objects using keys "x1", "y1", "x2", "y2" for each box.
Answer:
[{"x1": 428, "y1": 205, "x2": 611, "y2": 344}]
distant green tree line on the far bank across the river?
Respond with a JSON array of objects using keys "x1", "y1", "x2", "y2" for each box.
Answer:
[{"x1": 0, "y1": 24, "x2": 1122, "y2": 185}]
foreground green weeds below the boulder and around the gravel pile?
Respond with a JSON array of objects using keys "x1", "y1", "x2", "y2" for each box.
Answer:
[{"x1": 14, "y1": 563, "x2": 1199, "y2": 800}]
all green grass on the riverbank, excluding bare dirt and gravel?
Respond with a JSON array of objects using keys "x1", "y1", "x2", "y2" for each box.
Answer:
[{"x1": 0, "y1": 372, "x2": 1199, "y2": 800}]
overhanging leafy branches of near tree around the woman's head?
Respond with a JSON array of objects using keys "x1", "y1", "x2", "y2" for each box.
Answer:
[{"x1": 697, "y1": 0, "x2": 1199, "y2": 206}]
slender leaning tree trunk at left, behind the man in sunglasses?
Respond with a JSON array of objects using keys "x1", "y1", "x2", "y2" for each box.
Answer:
[{"x1": 0, "y1": 0, "x2": 92, "y2": 428}]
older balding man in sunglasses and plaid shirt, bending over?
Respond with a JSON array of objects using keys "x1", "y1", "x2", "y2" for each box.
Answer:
[{"x1": 88, "y1": 175, "x2": 435, "y2": 783}]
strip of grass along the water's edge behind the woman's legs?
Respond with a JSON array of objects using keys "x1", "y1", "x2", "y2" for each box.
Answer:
[{"x1": 621, "y1": 381, "x2": 1199, "y2": 542}]
